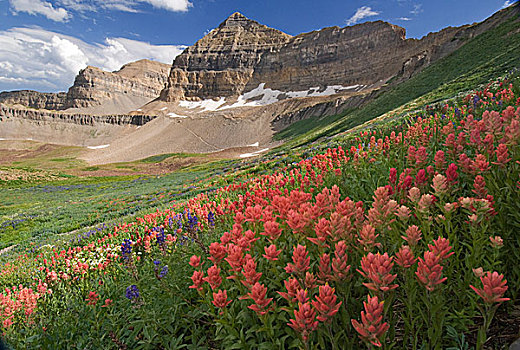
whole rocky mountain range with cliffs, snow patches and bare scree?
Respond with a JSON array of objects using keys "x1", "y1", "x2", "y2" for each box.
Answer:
[{"x1": 0, "y1": 6, "x2": 520, "y2": 163}]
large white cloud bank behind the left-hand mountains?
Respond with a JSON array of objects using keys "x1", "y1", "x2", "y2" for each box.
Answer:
[{"x1": 0, "y1": 28, "x2": 185, "y2": 91}]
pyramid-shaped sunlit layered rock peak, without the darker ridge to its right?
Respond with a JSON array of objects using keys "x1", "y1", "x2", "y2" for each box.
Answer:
[{"x1": 161, "y1": 12, "x2": 291, "y2": 102}]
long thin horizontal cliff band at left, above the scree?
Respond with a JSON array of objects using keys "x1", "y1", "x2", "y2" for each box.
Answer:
[{"x1": 0, "y1": 104, "x2": 156, "y2": 126}]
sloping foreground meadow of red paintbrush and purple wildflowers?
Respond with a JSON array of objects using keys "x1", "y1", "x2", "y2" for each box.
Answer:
[{"x1": 0, "y1": 73, "x2": 520, "y2": 349}]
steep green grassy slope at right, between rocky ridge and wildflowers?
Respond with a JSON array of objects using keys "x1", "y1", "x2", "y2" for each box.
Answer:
[{"x1": 278, "y1": 9, "x2": 520, "y2": 147}]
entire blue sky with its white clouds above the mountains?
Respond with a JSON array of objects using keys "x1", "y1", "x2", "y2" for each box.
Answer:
[{"x1": 0, "y1": 0, "x2": 513, "y2": 91}]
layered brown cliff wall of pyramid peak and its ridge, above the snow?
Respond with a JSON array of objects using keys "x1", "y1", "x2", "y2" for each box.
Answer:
[{"x1": 160, "y1": 6, "x2": 512, "y2": 102}]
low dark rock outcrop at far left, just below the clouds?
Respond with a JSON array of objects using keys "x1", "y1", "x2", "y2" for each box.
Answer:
[{"x1": 0, "y1": 90, "x2": 67, "y2": 110}]
